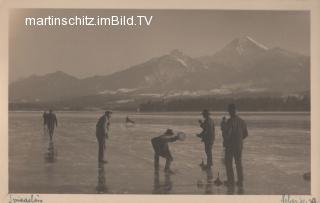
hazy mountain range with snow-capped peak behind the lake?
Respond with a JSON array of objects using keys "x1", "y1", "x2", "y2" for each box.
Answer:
[{"x1": 9, "y1": 37, "x2": 310, "y2": 106}]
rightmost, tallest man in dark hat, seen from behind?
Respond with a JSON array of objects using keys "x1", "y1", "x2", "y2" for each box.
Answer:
[{"x1": 225, "y1": 104, "x2": 248, "y2": 187}]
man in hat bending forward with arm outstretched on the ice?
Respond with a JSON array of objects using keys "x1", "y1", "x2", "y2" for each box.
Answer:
[{"x1": 151, "y1": 129, "x2": 179, "y2": 174}]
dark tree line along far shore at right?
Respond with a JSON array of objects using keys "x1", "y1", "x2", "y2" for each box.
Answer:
[{"x1": 139, "y1": 95, "x2": 310, "y2": 111}]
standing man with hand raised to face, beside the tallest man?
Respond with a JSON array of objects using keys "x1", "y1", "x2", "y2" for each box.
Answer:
[{"x1": 197, "y1": 109, "x2": 215, "y2": 169}]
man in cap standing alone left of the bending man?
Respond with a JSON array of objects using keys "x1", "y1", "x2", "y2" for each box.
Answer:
[{"x1": 96, "y1": 111, "x2": 112, "y2": 163}]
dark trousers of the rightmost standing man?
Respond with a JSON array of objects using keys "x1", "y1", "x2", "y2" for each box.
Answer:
[{"x1": 225, "y1": 146, "x2": 243, "y2": 184}]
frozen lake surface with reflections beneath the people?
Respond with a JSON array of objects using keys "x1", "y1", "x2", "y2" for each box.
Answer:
[{"x1": 9, "y1": 112, "x2": 311, "y2": 195}]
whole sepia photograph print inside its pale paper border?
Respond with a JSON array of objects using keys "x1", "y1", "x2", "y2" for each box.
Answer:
[{"x1": 8, "y1": 8, "x2": 313, "y2": 197}]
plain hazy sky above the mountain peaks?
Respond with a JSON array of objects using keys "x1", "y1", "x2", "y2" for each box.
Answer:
[{"x1": 9, "y1": 9, "x2": 310, "y2": 82}]
